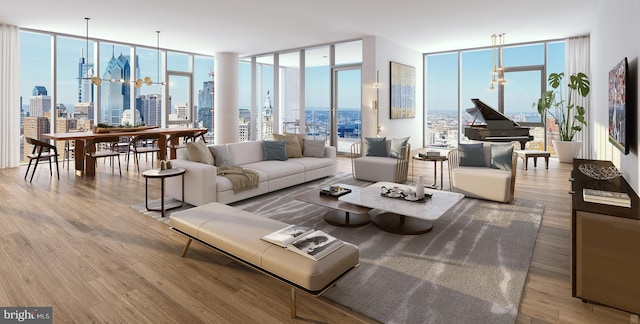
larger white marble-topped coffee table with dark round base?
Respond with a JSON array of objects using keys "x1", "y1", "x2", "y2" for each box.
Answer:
[{"x1": 338, "y1": 182, "x2": 464, "y2": 234}]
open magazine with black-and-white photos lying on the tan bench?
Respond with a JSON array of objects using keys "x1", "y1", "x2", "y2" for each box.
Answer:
[{"x1": 262, "y1": 225, "x2": 344, "y2": 261}]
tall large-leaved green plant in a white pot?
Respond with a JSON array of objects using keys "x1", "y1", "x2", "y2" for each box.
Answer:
[{"x1": 534, "y1": 72, "x2": 591, "y2": 163}]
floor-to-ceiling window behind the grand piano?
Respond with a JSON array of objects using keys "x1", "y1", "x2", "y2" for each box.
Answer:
[{"x1": 424, "y1": 41, "x2": 564, "y2": 150}]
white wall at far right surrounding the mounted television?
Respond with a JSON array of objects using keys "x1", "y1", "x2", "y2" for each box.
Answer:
[{"x1": 589, "y1": 0, "x2": 640, "y2": 193}]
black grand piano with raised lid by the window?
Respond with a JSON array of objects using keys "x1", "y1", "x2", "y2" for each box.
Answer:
[{"x1": 464, "y1": 99, "x2": 533, "y2": 150}]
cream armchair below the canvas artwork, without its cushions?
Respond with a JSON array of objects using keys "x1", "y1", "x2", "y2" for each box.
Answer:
[{"x1": 351, "y1": 139, "x2": 411, "y2": 183}]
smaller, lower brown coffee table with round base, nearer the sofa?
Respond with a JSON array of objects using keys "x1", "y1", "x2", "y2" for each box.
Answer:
[{"x1": 294, "y1": 184, "x2": 371, "y2": 227}]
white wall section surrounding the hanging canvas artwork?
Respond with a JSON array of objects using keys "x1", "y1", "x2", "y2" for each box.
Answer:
[{"x1": 362, "y1": 36, "x2": 424, "y2": 149}]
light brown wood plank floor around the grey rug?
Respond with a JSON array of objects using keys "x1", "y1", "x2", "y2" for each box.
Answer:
[{"x1": 0, "y1": 158, "x2": 640, "y2": 323}]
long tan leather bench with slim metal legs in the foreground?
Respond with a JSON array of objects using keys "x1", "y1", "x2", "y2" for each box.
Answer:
[{"x1": 169, "y1": 202, "x2": 360, "y2": 318}]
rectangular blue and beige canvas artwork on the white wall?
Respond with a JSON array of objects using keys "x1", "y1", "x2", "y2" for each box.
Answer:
[{"x1": 390, "y1": 62, "x2": 416, "y2": 119}]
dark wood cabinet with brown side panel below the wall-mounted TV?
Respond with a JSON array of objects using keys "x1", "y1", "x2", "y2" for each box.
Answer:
[{"x1": 571, "y1": 159, "x2": 640, "y2": 314}]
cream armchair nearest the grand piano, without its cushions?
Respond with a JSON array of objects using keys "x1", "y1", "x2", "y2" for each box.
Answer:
[{"x1": 448, "y1": 143, "x2": 518, "y2": 203}]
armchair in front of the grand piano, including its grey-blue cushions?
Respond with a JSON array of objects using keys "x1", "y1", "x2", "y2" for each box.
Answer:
[{"x1": 448, "y1": 143, "x2": 518, "y2": 203}]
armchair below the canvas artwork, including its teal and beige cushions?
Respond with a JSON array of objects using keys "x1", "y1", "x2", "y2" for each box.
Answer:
[{"x1": 351, "y1": 137, "x2": 411, "y2": 183}]
